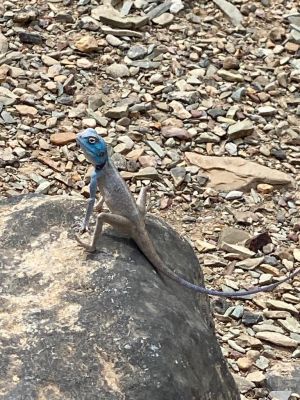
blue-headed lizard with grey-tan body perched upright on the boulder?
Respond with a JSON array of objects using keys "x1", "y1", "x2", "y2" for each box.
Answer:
[{"x1": 75, "y1": 128, "x2": 300, "y2": 297}]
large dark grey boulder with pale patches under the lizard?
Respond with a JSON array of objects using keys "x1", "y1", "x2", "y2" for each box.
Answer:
[{"x1": 0, "y1": 196, "x2": 240, "y2": 400}]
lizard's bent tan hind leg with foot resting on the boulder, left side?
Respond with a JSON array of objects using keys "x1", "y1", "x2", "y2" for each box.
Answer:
[{"x1": 75, "y1": 212, "x2": 132, "y2": 253}]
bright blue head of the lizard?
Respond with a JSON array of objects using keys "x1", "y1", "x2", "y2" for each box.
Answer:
[{"x1": 76, "y1": 128, "x2": 107, "y2": 169}]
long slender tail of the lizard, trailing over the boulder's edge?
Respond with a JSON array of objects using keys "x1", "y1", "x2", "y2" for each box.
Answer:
[{"x1": 134, "y1": 230, "x2": 300, "y2": 298}]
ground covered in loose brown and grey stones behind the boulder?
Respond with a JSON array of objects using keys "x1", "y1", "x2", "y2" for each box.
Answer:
[{"x1": 0, "y1": 0, "x2": 300, "y2": 400}]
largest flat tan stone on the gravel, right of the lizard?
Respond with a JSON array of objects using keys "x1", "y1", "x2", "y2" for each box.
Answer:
[{"x1": 185, "y1": 152, "x2": 292, "y2": 191}]
